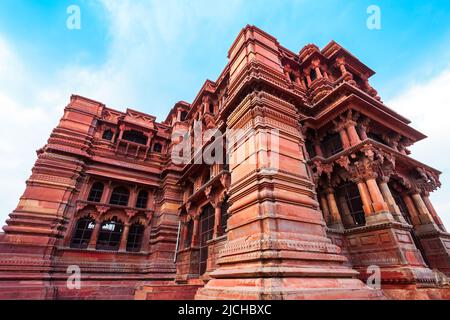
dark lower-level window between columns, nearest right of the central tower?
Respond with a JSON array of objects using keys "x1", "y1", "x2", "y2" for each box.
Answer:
[{"x1": 336, "y1": 182, "x2": 366, "y2": 226}]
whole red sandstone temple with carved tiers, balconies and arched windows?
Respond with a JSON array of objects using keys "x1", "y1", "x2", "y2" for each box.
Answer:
[{"x1": 0, "y1": 26, "x2": 450, "y2": 299}]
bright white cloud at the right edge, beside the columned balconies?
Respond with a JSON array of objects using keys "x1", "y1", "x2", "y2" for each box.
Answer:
[{"x1": 387, "y1": 66, "x2": 450, "y2": 230}]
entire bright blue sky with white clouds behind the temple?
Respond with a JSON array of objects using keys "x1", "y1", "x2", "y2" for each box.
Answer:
[{"x1": 0, "y1": 0, "x2": 450, "y2": 228}]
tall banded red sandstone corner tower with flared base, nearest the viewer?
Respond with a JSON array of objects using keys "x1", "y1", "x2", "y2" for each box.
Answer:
[{"x1": 196, "y1": 27, "x2": 381, "y2": 299}]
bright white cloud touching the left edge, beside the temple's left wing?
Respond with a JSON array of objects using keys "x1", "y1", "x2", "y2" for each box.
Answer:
[{"x1": 0, "y1": 36, "x2": 62, "y2": 225}]
